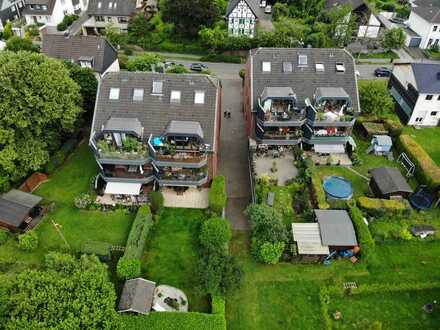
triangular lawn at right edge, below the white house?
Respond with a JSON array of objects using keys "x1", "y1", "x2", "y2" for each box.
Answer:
[{"x1": 403, "y1": 127, "x2": 440, "y2": 166}]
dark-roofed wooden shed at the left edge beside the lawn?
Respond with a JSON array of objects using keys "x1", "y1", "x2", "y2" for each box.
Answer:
[{"x1": 0, "y1": 189, "x2": 43, "y2": 232}]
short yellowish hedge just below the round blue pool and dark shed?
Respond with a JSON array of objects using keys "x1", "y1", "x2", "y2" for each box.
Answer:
[{"x1": 357, "y1": 196, "x2": 411, "y2": 217}]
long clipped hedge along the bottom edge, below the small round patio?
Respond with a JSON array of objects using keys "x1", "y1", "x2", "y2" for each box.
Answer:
[{"x1": 120, "y1": 312, "x2": 226, "y2": 330}]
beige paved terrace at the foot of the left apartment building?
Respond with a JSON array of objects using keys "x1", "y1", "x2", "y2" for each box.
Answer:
[{"x1": 162, "y1": 188, "x2": 209, "y2": 209}]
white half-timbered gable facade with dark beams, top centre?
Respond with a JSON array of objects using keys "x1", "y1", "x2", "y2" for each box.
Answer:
[{"x1": 228, "y1": 0, "x2": 257, "y2": 37}]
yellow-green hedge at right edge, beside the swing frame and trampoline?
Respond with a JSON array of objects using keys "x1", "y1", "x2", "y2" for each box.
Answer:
[{"x1": 398, "y1": 134, "x2": 440, "y2": 188}]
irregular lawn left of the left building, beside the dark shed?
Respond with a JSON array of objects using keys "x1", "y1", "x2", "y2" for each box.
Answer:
[{"x1": 0, "y1": 143, "x2": 133, "y2": 265}]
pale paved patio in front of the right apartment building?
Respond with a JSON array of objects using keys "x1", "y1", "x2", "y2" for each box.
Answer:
[{"x1": 253, "y1": 154, "x2": 298, "y2": 186}]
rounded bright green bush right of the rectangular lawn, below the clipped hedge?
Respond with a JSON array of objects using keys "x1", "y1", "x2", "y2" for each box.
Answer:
[{"x1": 199, "y1": 218, "x2": 232, "y2": 254}]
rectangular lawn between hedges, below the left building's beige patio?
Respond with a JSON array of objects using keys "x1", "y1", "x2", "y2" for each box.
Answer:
[{"x1": 142, "y1": 209, "x2": 210, "y2": 312}]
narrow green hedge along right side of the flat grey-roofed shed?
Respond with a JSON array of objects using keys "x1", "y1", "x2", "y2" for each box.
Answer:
[{"x1": 349, "y1": 206, "x2": 376, "y2": 265}]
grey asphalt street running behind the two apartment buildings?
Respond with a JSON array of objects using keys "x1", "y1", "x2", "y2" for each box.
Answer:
[{"x1": 174, "y1": 60, "x2": 392, "y2": 80}]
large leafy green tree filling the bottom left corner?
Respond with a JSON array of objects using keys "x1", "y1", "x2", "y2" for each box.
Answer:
[{"x1": 0, "y1": 255, "x2": 118, "y2": 329}]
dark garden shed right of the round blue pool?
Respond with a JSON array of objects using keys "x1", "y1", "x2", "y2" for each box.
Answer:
[{"x1": 370, "y1": 167, "x2": 413, "y2": 199}]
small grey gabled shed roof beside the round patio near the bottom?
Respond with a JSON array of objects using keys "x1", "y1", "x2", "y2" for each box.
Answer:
[{"x1": 118, "y1": 278, "x2": 156, "y2": 314}]
